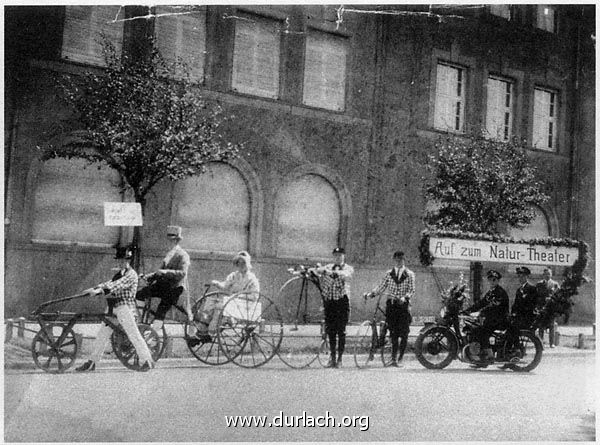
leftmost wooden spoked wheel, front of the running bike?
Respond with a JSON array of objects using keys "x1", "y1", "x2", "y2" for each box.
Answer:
[{"x1": 31, "y1": 325, "x2": 78, "y2": 374}]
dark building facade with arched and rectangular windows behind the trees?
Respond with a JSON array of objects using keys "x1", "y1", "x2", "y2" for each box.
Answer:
[{"x1": 4, "y1": 5, "x2": 595, "y2": 322}]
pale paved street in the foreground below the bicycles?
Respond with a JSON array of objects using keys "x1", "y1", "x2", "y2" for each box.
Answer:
[{"x1": 4, "y1": 353, "x2": 596, "y2": 442}]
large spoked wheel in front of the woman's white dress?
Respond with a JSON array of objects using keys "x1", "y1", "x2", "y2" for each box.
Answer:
[{"x1": 218, "y1": 294, "x2": 283, "y2": 368}]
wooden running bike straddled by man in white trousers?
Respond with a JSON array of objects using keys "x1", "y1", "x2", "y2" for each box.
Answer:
[{"x1": 31, "y1": 293, "x2": 160, "y2": 373}]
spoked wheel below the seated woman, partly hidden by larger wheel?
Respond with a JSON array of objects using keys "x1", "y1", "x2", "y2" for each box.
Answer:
[{"x1": 185, "y1": 292, "x2": 230, "y2": 365}]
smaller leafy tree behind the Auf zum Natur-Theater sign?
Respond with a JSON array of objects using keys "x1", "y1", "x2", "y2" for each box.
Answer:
[{"x1": 425, "y1": 135, "x2": 549, "y2": 234}]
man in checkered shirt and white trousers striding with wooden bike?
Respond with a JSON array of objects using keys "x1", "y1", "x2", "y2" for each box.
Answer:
[{"x1": 75, "y1": 247, "x2": 154, "y2": 372}]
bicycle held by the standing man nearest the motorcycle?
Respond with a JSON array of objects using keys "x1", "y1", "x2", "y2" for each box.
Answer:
[{"x1": 354, "y1": 294, "x2": 392, "y2": 368}]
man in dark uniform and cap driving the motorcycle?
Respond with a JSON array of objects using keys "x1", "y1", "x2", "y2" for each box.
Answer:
[{"x1": 466, "y1": 270, "x2": 508, "y2": 367}]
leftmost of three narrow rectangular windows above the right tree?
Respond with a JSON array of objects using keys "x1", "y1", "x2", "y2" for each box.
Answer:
[{"x1": 433, "y1": 63, "x2": 466, "y2": 132}]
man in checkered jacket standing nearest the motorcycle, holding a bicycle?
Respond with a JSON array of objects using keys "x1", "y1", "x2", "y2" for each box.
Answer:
[{"x1": 365, "y1": 251, "x2": 415, "y2": 367}]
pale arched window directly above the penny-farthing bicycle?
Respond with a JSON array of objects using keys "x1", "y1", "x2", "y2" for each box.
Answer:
[{"x1": 276, "y1": 174, "x2": 340, "y2": 258}]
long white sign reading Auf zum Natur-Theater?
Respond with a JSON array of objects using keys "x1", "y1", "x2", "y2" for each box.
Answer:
[{"x1": 429, "y1": 237, "x2": 579, "y2": 266}]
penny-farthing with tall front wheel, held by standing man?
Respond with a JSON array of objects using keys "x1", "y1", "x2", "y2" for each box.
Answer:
[{"x1": 278, "y1": 265, "x2": 329, "y2": 369}]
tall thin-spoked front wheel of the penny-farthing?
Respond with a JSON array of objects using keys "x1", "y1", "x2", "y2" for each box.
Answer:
[{"x1": 278, "y1": 276, "x2": 323, "y2": 369}]
